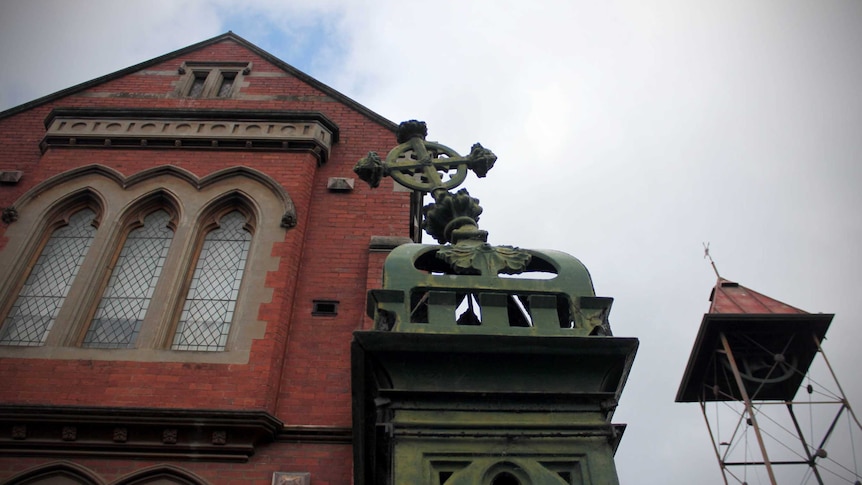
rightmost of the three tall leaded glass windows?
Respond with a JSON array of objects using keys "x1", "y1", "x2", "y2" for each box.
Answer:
[{"x1": 171, "y1": 211, "x2": 251, "y2": 351}]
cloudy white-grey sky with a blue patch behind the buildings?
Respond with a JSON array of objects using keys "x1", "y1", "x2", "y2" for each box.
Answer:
[{"x1": 0, "y1": 0, "x2": 862, "y2": 485}]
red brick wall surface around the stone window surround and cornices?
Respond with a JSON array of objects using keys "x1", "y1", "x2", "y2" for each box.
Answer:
[{"x1": 0, "y1": 36, "x2": 409, "y2": 485}]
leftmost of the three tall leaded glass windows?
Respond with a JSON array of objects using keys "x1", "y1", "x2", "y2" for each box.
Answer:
[{"x1": 0, "y1": 209, "x2": 96, "y2": 346}]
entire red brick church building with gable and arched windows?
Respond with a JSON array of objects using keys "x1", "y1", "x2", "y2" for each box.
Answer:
[{"x1": 0, "y1": 33, "x2": 416, "y2": 485}]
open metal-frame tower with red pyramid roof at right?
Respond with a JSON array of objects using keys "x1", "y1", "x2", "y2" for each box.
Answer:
[{"x1": 676, "y1": 277, "x2": 862, "y2": 485}]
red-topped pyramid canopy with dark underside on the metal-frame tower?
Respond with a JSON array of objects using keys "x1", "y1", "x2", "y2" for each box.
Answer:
[{"x1": 676, "y1": 278, "x2": 833, "y2": 402}]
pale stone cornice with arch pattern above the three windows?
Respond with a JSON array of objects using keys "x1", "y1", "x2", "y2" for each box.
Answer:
[{"x1": 40, "y1": 109, "x2": 338, "y2": 163}]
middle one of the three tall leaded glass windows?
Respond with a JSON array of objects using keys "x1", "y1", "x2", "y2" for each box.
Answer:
[{"x1": 83, "y1": 210, "x2": 174, "y2": 349}]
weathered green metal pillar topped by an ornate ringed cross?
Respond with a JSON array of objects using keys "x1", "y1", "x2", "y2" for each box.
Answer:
[{"x1": 352, "y1": 121, "x2": 638, "y2": 485}]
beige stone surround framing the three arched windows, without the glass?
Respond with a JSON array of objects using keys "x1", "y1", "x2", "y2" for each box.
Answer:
[{"x1": 0, "y1": 165, "x2": 288, "y2": 363}]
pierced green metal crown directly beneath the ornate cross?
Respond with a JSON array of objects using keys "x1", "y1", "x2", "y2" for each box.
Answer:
[{"x1": 368, "y1": 243, "x2": 613, "y2": 336}]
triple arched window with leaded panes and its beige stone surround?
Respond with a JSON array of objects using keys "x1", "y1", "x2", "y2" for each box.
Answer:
[{"x1": 0, "y1": 165, "x2": 294, "y2": 363}]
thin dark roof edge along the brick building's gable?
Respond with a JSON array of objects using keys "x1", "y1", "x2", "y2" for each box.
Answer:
[{"x1": 0, "y1": 31, "x2": 398, "y2": 132}]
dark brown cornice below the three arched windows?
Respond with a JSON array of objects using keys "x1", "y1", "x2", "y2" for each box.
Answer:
[{"x1": 0, "y1": 406, "x2": 284, "y2": 462}]
